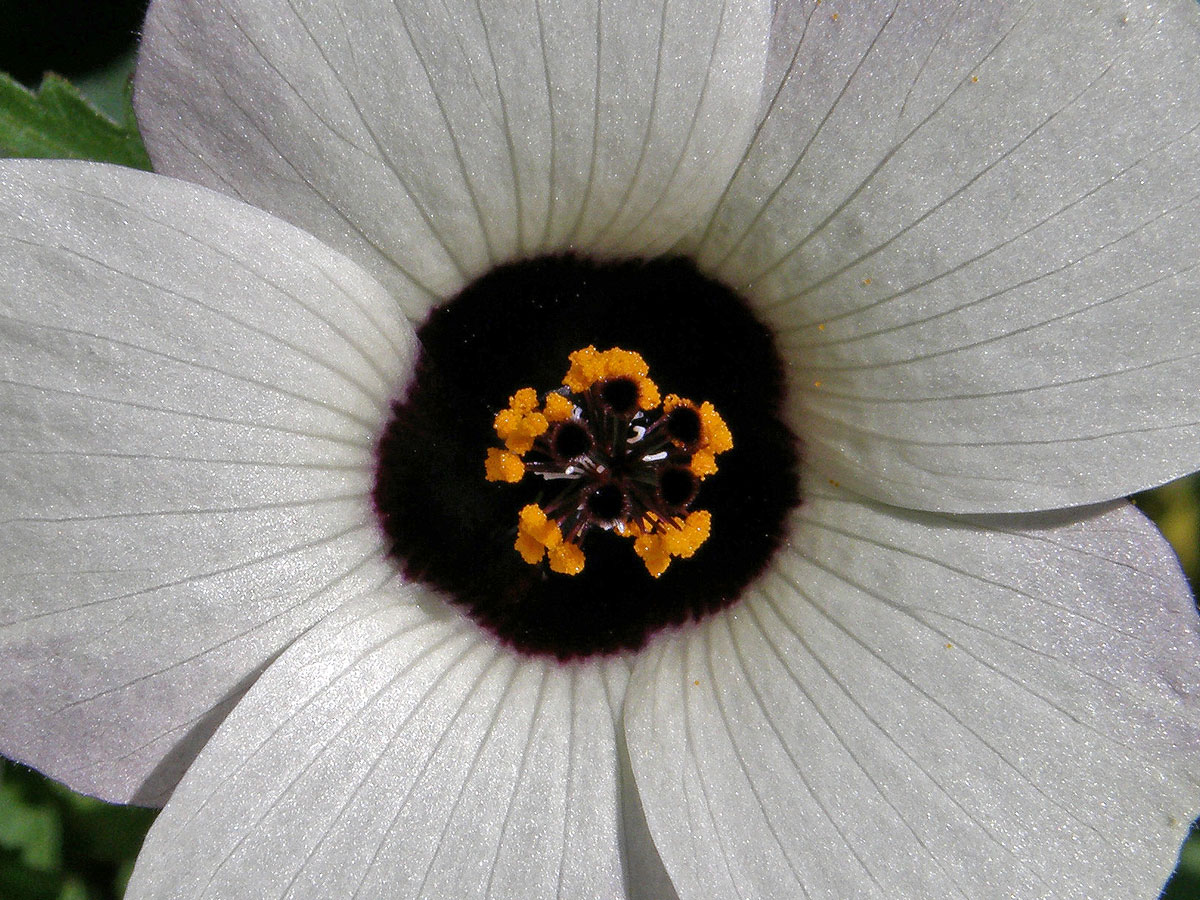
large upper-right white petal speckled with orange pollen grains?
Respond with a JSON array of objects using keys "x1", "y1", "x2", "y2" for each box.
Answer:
[{"x1": 700, "y1": 0, "x2": 1200, "y2": 512}]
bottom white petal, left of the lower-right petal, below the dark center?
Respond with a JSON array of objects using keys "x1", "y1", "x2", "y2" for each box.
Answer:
[{"x1": 128, "y1": 584, "x2": 624, "y2": 900}]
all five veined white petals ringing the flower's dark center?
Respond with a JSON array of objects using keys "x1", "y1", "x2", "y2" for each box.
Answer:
[{"x1": 0, "y1": 0, "x2": 1200, "y2": 900}]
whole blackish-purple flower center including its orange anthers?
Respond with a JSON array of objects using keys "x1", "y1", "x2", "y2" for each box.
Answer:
[{"x1": 374, "y1": 256, "x2": 799, "y2": 660}]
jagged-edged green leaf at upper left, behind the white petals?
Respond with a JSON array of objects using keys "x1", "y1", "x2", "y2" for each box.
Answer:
[{"x1": 0, "y1": 72, "x2": 150, "y2": 169}]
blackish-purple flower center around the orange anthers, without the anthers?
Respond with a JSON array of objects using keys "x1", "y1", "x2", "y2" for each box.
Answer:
[{"x1": 374, "y1": 256, "x2": 799, "y2": 660}]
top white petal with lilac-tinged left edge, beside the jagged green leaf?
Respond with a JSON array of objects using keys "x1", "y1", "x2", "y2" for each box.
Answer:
[{"x1": 136, "y1": 0, "x2": 769, "y2": 317}]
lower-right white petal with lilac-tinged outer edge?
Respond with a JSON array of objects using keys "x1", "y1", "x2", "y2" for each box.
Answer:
[{"x1": 626, "y1": 486, "x2": 1200, "y2": 900}]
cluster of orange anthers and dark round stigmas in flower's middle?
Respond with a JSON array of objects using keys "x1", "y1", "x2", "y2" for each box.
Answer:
[{"x1": 484, "y1": 347, "x2": 733, "y2": 578}]
